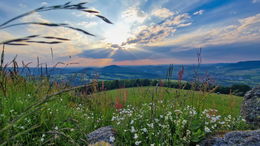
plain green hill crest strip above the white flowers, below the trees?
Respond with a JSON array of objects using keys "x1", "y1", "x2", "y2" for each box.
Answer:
[{"x1": 99, "y1": 87, "x2": 243, "y2": 116}]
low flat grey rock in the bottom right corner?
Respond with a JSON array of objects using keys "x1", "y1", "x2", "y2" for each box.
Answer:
[{"x1": 200, "y1": 129, "x2": 260, "y2": 146}]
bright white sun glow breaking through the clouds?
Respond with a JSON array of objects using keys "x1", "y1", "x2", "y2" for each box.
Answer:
[{"x1": 104, "y1": 23, "x2": 130, "y2": 45}]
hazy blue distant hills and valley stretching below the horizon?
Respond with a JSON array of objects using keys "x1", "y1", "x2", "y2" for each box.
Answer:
[{"x1": 23, "y1": 61, "x2": 260, "y2": 86}]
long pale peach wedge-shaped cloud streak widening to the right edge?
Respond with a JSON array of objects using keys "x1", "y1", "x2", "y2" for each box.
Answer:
[{"x1": 151, "y1": 14, "x2": 260, "y2": 50}]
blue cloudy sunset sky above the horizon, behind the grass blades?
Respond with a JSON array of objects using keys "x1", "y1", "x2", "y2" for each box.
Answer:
[{"x1": 0, "y1": 0, "x2": 260, "y2": 66}]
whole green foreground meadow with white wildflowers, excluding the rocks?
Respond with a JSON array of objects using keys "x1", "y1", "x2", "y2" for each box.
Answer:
[{"x1": 0, "y1": 76, "x2": 247, "y2": 145}]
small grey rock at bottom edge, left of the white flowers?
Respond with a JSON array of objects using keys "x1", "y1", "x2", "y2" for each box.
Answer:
[{"x1": 87, "y1": 126, "x2": 116, "y2": 145}]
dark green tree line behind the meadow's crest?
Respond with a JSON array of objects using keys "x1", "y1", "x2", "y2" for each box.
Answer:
[{"x1": 94, "y1": 79, "x2": 251, "y2": 96}]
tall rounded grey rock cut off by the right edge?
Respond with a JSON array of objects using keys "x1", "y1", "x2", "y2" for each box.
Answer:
[{"x1": 241, "y1": 86, "x2": 260, "y2": 128}]
